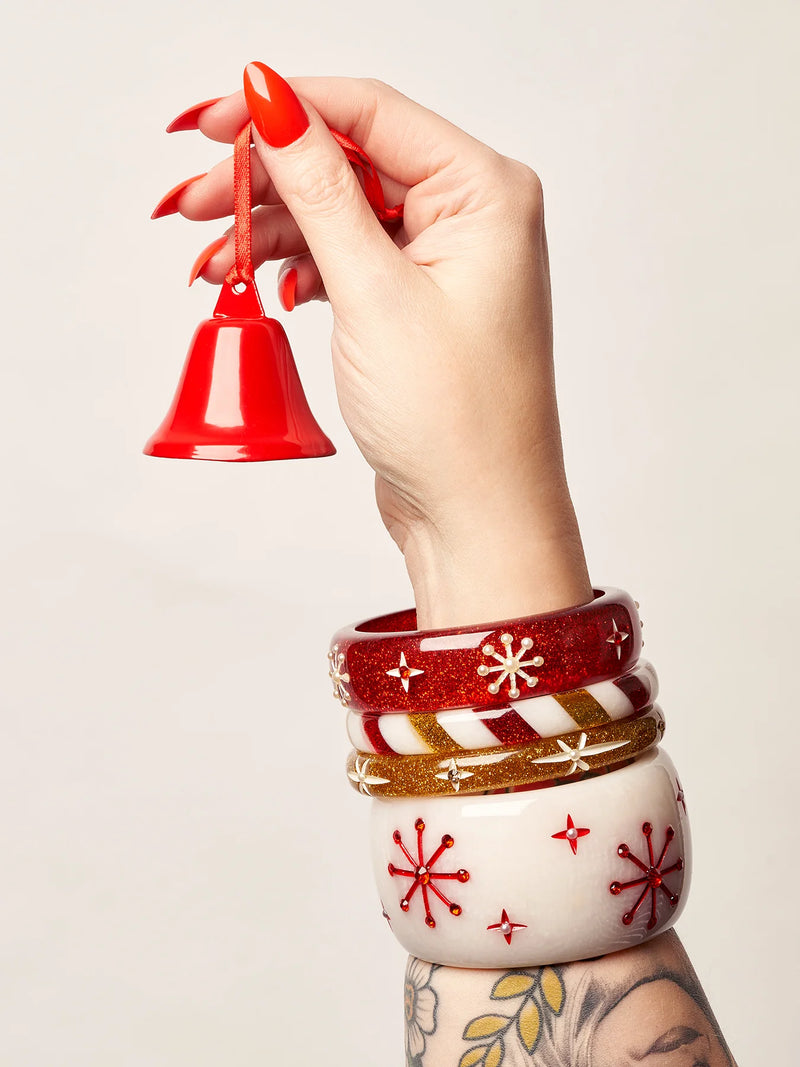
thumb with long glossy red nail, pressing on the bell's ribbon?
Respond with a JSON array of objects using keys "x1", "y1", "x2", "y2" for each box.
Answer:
[{"x1": 244, "y1": 63, "x2": 405, "y2": 312}]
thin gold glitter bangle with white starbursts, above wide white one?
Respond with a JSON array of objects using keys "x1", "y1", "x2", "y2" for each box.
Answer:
[{"x1": 347, "y1": 704, "x2": 665, "y2": 797}]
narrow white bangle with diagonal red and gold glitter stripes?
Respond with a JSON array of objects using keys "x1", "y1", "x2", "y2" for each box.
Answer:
[{"x1": 347, "y1": 660, "x2": 658, "y2": 755}]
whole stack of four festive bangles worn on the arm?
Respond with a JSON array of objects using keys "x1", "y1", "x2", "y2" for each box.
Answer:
[{"x1": 329, "y1": 589, "x2": 691, "y2": 968}]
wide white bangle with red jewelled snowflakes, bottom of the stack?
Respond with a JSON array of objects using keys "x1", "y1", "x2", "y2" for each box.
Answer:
[{"x1": 371, "y1": 749, "x2": 691, "y2": 968}]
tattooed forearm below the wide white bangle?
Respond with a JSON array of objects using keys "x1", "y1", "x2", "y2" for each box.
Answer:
[{"x1": 405, "y1": 930, "x2": 735, "y2": 1067}]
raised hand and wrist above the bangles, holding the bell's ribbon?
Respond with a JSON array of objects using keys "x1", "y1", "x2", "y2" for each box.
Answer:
[{"x1": 157, "y1": 64, "x2": 592, "y2": 625}]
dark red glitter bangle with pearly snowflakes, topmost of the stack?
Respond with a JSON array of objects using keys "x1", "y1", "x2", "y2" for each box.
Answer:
[{"x1": 327, "y1": 589, "x2": 642, "y2": 715}]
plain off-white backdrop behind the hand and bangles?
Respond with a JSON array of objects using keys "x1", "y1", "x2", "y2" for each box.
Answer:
[{"x1": 0, "y1": 0, "x2": 800, "y2": 1067}]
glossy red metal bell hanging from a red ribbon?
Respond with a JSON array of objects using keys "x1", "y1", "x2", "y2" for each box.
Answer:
[{"x1": 144, "y1": 281, "x2": 336, "y2": 462}]
